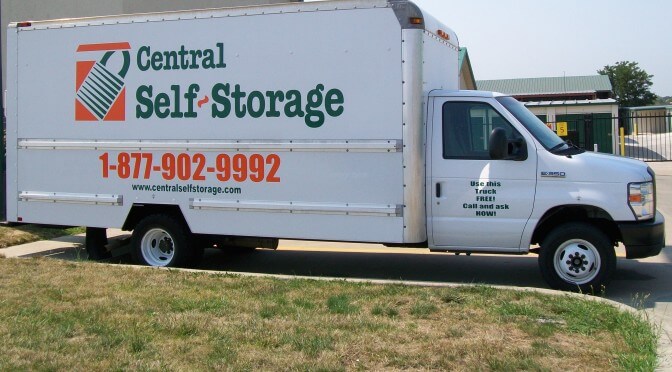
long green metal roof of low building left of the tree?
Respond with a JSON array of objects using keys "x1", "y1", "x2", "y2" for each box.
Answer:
[{"x1": 476, "y1": 75, "x2": 612, "y2": 95}]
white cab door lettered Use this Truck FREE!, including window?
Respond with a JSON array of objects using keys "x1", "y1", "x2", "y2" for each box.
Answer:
[{"x1": 428, "y1": 97, "x2": 537, "y2": 251}]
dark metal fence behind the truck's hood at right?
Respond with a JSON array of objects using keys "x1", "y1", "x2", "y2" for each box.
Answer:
[{"x1": 547, "y1": 112, "x2": 672, "y2": 161}]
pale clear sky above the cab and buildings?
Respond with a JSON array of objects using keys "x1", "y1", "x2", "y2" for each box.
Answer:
[{"x1": 310, "y1": 0, "x2": 672, "y2": 96}]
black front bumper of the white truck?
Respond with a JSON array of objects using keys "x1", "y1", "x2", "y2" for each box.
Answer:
[{"x1": 618, "y1": 211, "x2": 665, "y2": 258}]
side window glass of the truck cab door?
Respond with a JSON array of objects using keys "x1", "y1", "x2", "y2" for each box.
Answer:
[{"x1": 443, "y1": 102, "x2": 521, "y2": 160}]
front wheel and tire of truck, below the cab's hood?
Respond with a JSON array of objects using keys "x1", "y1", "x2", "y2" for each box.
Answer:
[{"x1": 539, "y1": 223, "x2": 616, "y2": 294}]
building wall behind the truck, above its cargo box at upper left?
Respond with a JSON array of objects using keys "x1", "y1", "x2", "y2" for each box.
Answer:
[{"x1": 0, "y1": 0, "x2": 302, "y2": 97}]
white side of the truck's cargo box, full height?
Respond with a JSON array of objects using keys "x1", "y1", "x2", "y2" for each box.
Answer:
[{"x1": 9, "y1": 4, "x2": 404, "y2": 242}]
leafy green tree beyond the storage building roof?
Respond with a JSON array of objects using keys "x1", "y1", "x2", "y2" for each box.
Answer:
[{"x1": 597, "y1": 61, "x2": 658, "y2": 107}]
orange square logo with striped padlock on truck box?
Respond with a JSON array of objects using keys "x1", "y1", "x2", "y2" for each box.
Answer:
[{"x1": 75, "y1": 42, "x2": 131, "y2": 121}]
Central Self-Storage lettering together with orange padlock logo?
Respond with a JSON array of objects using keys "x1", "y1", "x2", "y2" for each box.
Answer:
[{"x1": 75, "y1": 42, "x2": 345, "y2": 128}]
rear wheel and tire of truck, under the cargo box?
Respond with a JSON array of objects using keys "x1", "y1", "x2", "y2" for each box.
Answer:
[{"x1": 131, "y1": 214, "x2": 193, "y2": 267}]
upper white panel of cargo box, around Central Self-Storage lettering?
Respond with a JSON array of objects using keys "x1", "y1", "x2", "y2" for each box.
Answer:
[{"x1": 18, "y1": 9, "x2": 401, "y2": 140}]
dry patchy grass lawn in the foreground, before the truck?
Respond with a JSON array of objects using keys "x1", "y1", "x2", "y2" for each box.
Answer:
[{"x1": 0, "y1": 259, "x2": 657, "y2": 371}]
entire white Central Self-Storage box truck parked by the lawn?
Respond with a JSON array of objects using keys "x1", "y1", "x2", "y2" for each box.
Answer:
[{"x1": 7, "y1": 0, "x2": 664, "y2": 290}]
